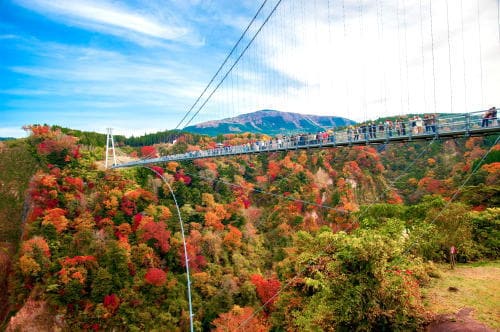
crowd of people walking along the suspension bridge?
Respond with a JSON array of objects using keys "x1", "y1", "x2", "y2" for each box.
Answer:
[{"x1": 147, "y1": 107, "x2": 498, "y2": 160}]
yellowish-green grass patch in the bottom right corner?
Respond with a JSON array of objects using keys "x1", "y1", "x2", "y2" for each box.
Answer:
[{"x1": 422, "y1": 261, "x2": 500, "y2": 330}]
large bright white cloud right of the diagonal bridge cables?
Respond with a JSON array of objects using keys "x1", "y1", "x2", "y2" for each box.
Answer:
[{"x1": 195, "y1": 0, "x2": 500, "y2": 122}]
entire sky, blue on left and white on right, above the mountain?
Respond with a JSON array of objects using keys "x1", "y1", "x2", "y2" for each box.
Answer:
[{"x1": 0, "y1": 0, "x2": 500, "y2": 137}]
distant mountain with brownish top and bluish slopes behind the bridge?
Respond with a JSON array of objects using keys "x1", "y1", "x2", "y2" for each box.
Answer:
[{"x1": 184, "y1": 110, "x2": 355, "y2": 136}]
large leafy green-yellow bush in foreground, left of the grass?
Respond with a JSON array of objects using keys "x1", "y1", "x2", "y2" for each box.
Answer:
[{"x1": 273, "y1": 230, "x2": 424, "y2": 331}]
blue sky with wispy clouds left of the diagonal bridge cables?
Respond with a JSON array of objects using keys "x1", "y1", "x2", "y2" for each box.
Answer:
[{"x1": 0, "y1": 0, "x2": 259, "y2": 136}]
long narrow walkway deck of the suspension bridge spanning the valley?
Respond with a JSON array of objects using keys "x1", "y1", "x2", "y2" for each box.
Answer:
[{"x1": 113, "y1": 112, "x2": 500, "y2": 168}]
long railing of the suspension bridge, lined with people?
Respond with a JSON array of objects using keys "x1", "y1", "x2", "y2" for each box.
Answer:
[{"x1": 114, "y1": 111, "x2": 499, "y2": 167}]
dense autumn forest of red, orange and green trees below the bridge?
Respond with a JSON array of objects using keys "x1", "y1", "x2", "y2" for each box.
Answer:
[{"x1": 0, "y1": 125, "x2": 500, "y2": 331}]
